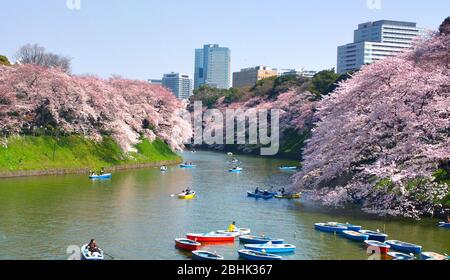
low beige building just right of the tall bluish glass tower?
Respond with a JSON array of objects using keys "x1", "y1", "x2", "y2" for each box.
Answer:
[{"x1": 233, "y1": 66, "x2": 278, "y2": 88}]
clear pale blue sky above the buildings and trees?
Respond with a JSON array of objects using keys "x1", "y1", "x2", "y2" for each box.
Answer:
[{"x1": 0, "y1": 0, "x2": 450, "y2": 79}]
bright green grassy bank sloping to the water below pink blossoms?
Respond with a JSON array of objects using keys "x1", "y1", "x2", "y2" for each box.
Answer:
[{"x1": 0, "y1": 135, "x2": 180, "y2": 173}]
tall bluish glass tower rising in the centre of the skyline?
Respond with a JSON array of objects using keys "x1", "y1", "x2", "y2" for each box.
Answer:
[{"x1": 194, "y1": 45, "x2": 231, "y2": 89}]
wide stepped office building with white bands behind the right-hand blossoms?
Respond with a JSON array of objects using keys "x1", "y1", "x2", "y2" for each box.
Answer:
[{"x1": 337, "y1": 20, "x2": 424, "y2": 74}]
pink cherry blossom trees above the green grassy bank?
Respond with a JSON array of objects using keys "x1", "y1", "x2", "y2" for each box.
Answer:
[{"x1": 0, "y1": 65, "x2": 191, "y2": 151}]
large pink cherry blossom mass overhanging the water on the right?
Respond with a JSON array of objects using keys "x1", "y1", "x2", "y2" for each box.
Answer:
[{"x1": 294, "y1": 34, "x2": 450, "y2": 217}]
